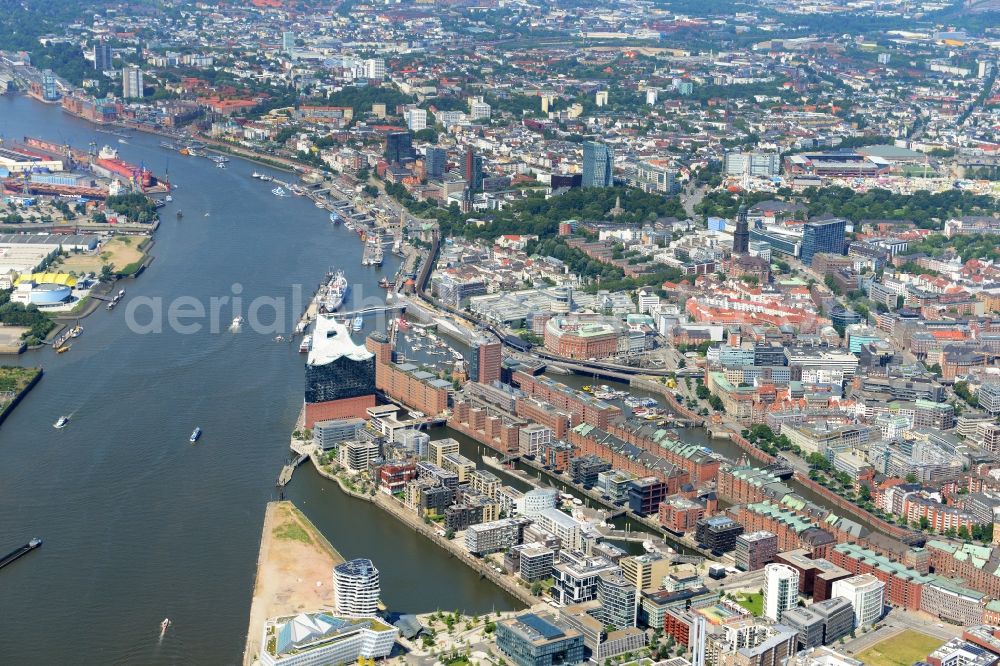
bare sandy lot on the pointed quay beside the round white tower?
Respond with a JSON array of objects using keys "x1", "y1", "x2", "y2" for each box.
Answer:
[{"x1": 243, "y1": 502, "x2": 344, "y2": 665}]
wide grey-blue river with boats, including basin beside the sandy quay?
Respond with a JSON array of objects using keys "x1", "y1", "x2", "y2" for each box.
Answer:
[{"x1": 0, "y1": 96, "x2": 516, "y2": 665}]
